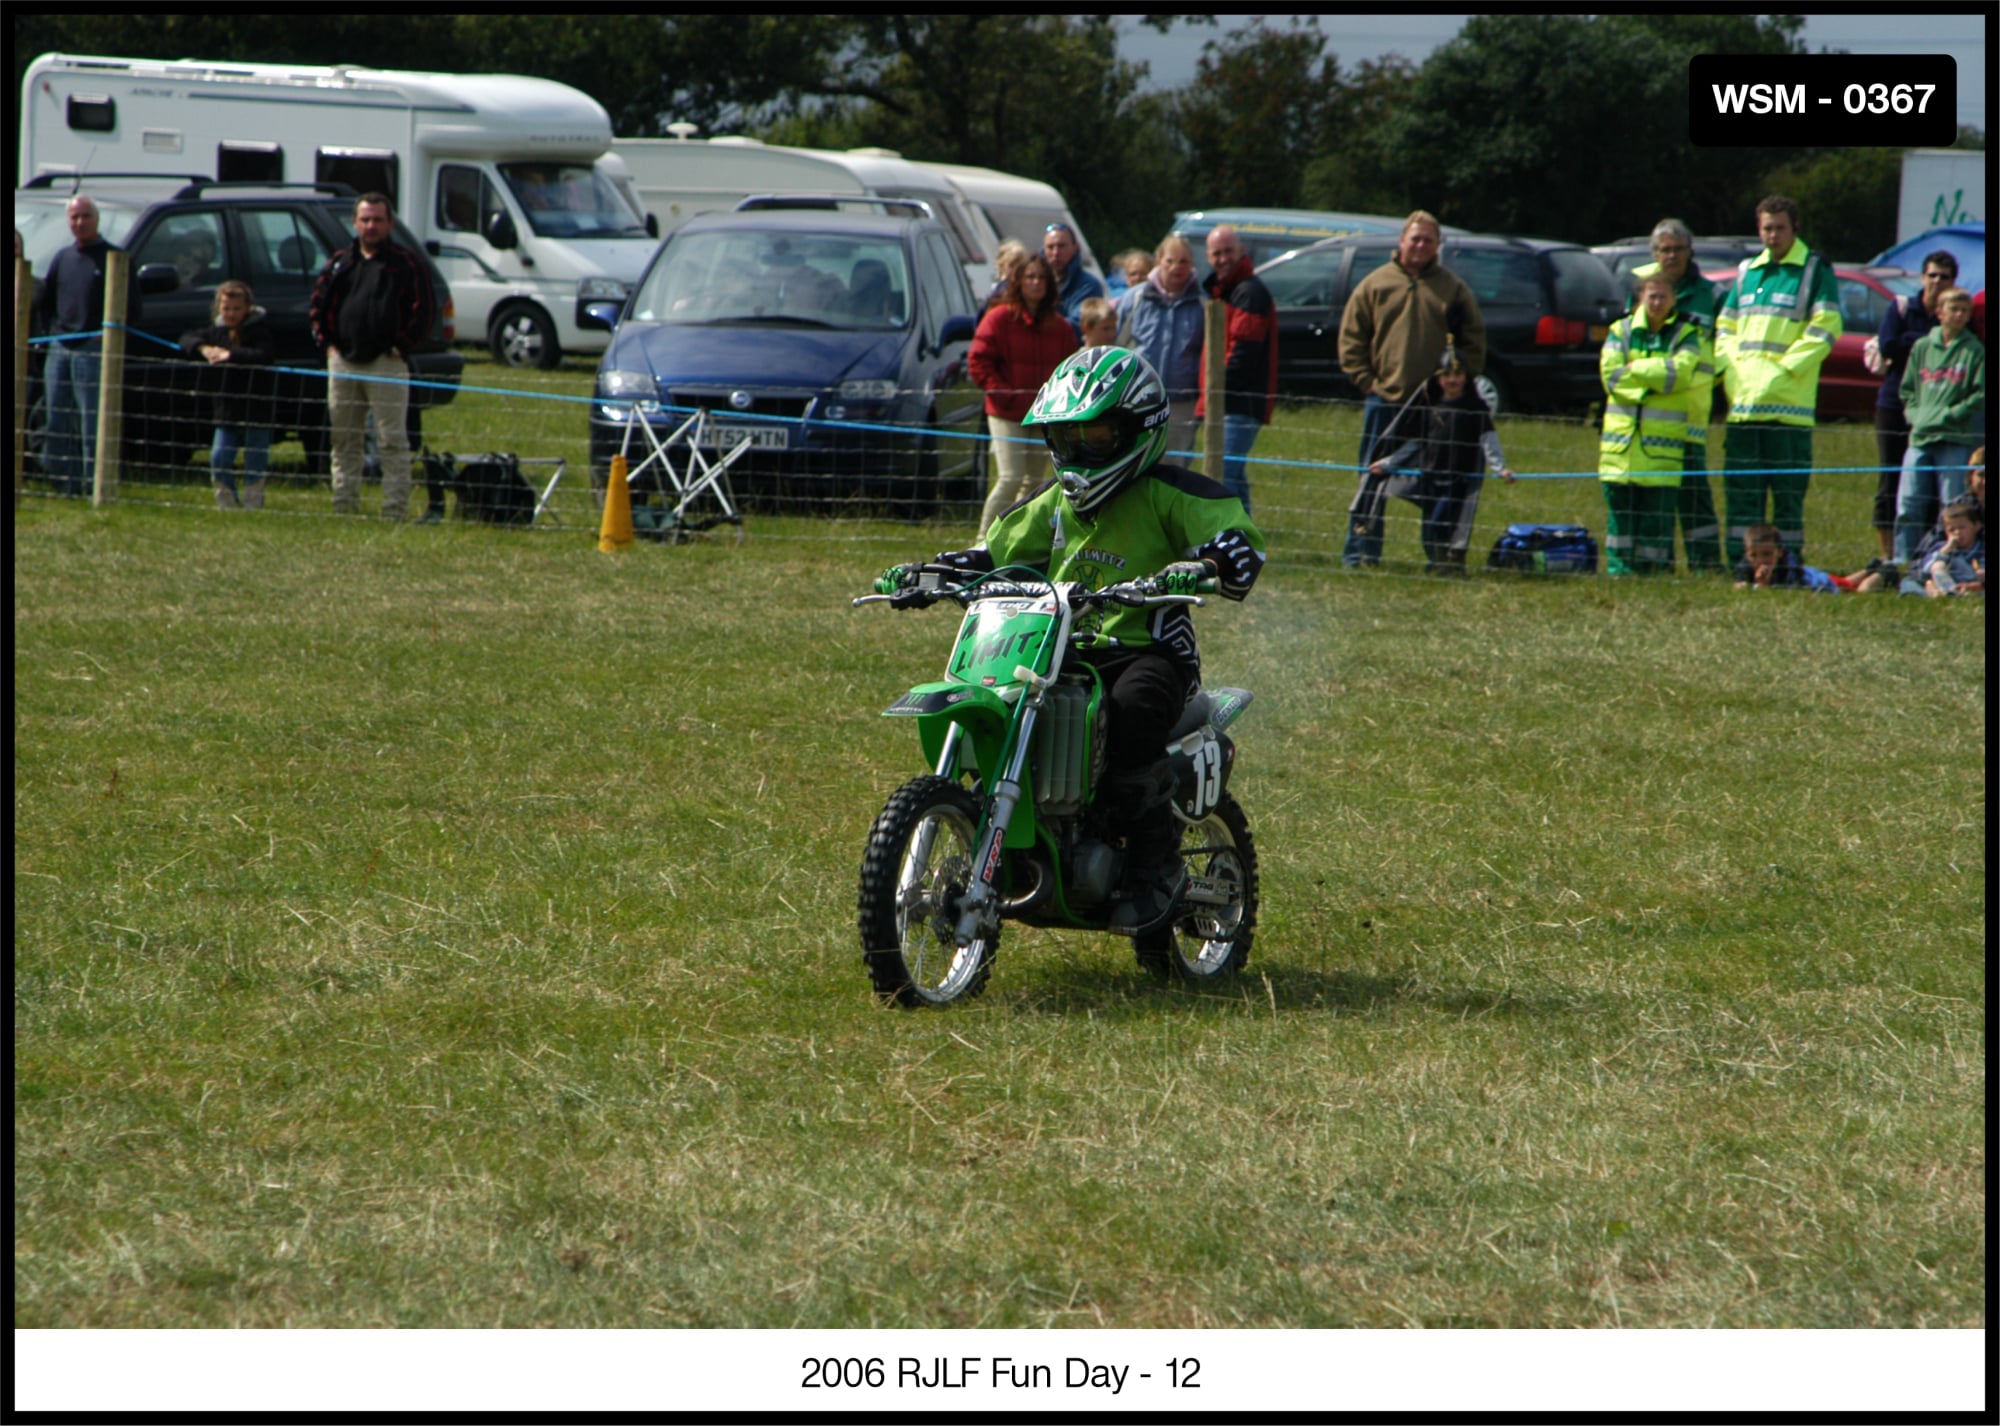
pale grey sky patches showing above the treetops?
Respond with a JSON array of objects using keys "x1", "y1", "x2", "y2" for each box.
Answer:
[{"x1": 1118, "y1": 10, "x2": 1992, "y2": 130}]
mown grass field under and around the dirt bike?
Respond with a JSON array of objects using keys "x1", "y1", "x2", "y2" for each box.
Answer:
[{"x1": 14, "y1": 362, "x2": 1988, "y2": 1328}]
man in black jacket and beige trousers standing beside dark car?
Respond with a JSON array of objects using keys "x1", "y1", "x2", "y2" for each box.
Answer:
[{"x1": 312, "y1": 194, "x2": 432, "y2": 520}]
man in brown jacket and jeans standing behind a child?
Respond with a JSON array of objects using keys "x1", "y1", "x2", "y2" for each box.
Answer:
[{"x1": 1340, "y1": 208, "x2": 1486, "y2": 568}]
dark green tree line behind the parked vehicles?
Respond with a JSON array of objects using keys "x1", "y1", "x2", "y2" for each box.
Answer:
[{"x1": 10, "y1": 10, "x2": 1984, "y2": 260}]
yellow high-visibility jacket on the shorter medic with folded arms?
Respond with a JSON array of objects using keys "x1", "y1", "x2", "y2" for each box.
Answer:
[{"x1": 1598, "y1": 312, "x2": 1702, "y2": 486}]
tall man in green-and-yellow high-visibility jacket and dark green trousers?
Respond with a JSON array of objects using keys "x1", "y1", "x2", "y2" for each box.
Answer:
[{"x1": 1716, "y1": 196, "x2": 1840, "y2": 566}]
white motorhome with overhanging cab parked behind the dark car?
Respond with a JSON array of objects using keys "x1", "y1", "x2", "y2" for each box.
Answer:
[{"x1": 20, "y1": 54, "x2": 656, "y2": 366}]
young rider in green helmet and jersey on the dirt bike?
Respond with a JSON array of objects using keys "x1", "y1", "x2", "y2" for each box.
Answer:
[{"x1": 878, "y1": 346, "x2": 1264, "y2": 936}]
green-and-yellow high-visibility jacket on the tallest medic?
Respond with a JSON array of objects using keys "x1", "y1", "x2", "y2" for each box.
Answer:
[{"x1": 1716, "y1": 240, "x2": 1840, "y2": 428}]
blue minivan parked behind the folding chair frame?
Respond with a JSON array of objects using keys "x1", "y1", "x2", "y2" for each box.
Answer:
[{"x1": 578, "y1": 194, "x2": 986, "y2": 516}]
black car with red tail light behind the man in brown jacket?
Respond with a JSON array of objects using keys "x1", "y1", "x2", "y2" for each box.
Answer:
[{"x1": 1258, "y1": 234, "x2": 1624, "y2": 416}]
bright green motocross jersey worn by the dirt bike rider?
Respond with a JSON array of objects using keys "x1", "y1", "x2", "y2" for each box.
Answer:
[{"x1": 986, "y1": 464, "x2": 1264, "y2": 668}]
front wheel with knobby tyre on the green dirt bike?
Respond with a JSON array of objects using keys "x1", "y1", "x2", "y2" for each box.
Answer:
[{"x1": 860, "y1": 776, "x2": 1000, "y2": 1008}]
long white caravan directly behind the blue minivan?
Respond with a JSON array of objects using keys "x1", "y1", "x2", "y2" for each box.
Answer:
[{"x1": 612, "y1": 134, "x2": 1000, "y2": 292}]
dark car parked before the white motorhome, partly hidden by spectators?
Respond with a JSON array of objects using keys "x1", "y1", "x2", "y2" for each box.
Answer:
[{"x1": 14, "y1": 174, "x2": 466, "y2": 470}]
